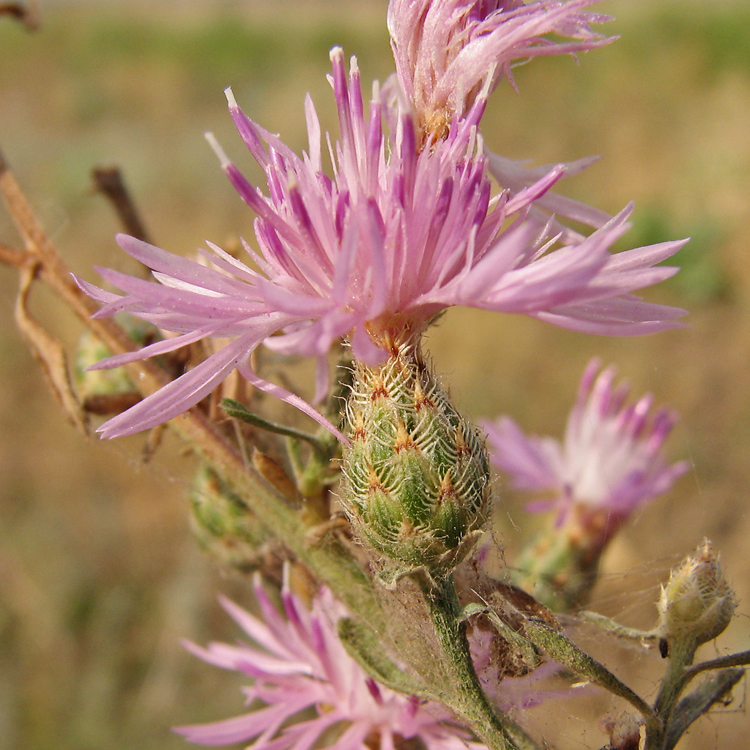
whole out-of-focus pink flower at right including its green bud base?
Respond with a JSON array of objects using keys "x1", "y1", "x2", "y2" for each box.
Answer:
[{"x1": 484, "y1": 359, "x2": 688, "y2": 612}]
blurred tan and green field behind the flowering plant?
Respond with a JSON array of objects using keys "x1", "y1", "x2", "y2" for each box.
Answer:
[{"x1": 0, "y1": 0, "x2": 750, "y2": 750}]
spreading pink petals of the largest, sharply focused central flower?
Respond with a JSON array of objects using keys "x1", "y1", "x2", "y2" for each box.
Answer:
[{"x1": 79, "y1": 48, "x2": 684, "y2": 437}]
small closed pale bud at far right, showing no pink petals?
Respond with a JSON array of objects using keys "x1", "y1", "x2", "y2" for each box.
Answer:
[{"x1": 657, "y1": 540, "x2": 737, "y2": 651}]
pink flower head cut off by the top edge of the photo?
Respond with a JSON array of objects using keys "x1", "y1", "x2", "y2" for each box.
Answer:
[{"x1": 388, "y1": 0, "x2": 611, "y2": 140}]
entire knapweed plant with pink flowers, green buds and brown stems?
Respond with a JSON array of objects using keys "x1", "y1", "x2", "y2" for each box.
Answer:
[{"x1": 0, "y1": 0, "x2": 750, "y2": 750}]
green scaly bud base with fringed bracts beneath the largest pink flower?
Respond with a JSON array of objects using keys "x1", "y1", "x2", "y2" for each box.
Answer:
[{"x1": 342, "y1": 342, "x2": 490, "y2": 575}]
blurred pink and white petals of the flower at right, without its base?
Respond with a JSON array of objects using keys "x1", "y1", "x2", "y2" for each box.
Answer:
[{"x1": 485, "y1": 359, "x2": 689, "y2": 532}]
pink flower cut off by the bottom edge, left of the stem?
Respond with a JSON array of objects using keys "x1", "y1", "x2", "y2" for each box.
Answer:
[{"x1": 176, "y1": 578, "x2": 485, "y2": 750}]
